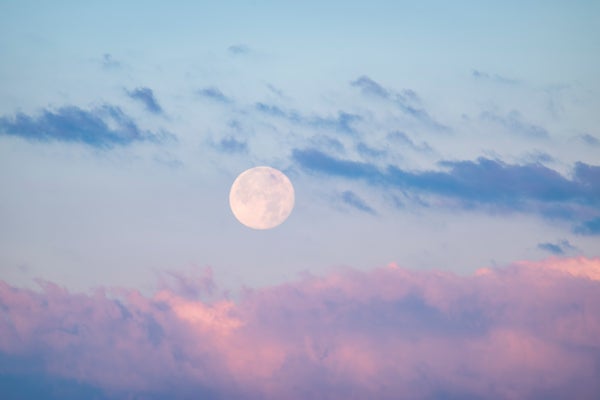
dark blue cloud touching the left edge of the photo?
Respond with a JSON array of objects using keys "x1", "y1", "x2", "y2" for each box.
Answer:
[{"x1": 0, "y1": 104, "x2": 170, "y2": 148}]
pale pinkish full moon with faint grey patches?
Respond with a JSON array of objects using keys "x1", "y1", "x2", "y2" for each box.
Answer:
[{"x1": 229, "y1": 167, "x2": 294, "y2": 229}]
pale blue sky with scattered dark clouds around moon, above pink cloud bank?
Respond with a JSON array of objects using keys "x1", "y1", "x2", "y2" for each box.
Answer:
[{"x1": 0, "y1": 1, "x2": 600, "y2": 289}]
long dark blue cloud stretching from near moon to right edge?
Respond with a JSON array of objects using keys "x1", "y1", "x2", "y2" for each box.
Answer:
[{"x1": 292, "y1": 149, "x2": 600, "y2": 227}]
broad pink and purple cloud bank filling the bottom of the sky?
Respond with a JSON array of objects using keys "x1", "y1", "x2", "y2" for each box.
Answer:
[{"x1": 0, "y1": 258, "x2": 600, "y2": 400}]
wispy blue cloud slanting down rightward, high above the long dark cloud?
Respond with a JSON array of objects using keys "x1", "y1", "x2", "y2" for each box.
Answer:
[{"x1": 350, "y1": 75, "x2": 448, "y2": 131}]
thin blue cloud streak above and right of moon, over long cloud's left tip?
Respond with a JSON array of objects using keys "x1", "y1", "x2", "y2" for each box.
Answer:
[{"x1": 255, "y1": 102, "x2": 362, "y2": 134}]
